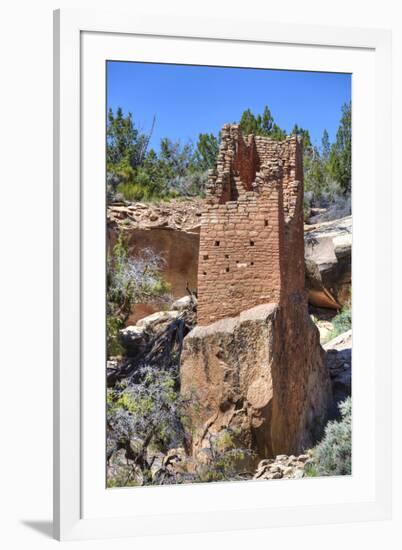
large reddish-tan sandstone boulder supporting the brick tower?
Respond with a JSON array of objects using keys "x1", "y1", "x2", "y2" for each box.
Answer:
[{"x1": 181, "y1": 300, "x2": 332, "y2": 458}]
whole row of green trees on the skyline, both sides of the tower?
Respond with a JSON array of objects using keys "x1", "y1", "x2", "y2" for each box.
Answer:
[{"x1": 106, "y1": 103, "x2": 351, "y2": 213}]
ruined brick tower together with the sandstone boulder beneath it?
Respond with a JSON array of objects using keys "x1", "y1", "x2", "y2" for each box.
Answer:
[{"x1": 180, "y1": 125, "x2": 332, "y2": 458}]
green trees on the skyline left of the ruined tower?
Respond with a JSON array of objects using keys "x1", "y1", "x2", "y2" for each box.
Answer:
[{"x1": 106, "y1": 108, "x2": 219, "y2": 201}]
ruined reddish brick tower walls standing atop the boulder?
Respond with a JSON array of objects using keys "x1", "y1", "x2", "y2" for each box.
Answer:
[{"x1": 198, "y1": 125, "x2": 304, "y2": 325}]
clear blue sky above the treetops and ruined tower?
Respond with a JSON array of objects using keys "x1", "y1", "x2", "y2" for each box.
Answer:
[{"x1": 107, "y1": 61, "x2": 351, "y2": 151}]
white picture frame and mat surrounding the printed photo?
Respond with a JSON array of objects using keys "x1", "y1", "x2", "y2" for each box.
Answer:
[{"x1": 54, "y1": 10, "x2": 391, "y2": 540}]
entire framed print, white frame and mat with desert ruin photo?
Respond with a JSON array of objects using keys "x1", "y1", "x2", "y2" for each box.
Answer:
[{"x1": 54, "y1": 10, "x2": 391, "y2": 539}]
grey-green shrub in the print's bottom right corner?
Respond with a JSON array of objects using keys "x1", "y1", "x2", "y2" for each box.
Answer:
[{"x1": 305, "y1": 397, "x2": 352, "y2": 477}]
